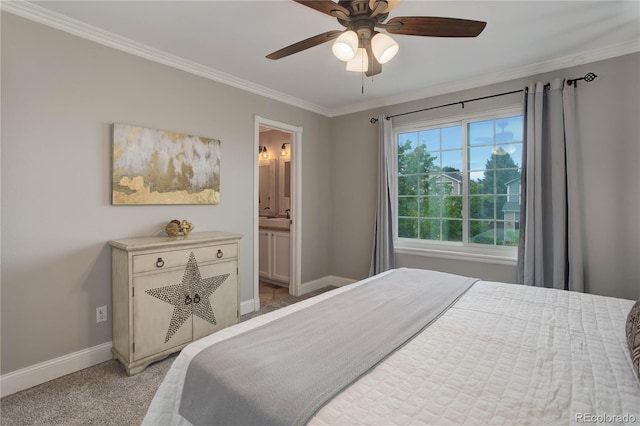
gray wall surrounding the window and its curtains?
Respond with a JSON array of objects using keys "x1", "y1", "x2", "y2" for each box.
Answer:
[{"x1": 331, "y1": 54, "x2": 640, "y2": 299}]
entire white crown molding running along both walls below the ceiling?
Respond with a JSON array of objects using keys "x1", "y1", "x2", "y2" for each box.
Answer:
[{"x1": 0, "y1": 0, "x2": 640, "y2": 118}]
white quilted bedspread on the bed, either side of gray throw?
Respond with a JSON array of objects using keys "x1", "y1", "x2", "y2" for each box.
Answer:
[{"x1": 143, "y1": 268, "x2": 640, "y2": 425}]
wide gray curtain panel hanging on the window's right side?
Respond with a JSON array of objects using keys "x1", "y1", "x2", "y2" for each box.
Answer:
[{"x1": 518, "y1": 79, "x2": 584, "y2": 291}]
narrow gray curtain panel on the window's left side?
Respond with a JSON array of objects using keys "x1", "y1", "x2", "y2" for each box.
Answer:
[{"x1": 369, "y1": 115, "x2": 396, "y2": 276}]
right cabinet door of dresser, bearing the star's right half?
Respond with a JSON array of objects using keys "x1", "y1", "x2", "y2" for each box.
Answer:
[{"x1": 193, "y1": 260, "x2": 240, "y2": 340}]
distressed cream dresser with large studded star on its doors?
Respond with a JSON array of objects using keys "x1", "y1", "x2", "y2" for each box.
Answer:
[{"x1": 109, "y1": 232, "x2": 242, "y2": 375}]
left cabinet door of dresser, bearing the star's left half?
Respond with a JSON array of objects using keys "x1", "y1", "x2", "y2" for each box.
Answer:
[{"x1": 133, "y1": 268, "x2": 193, "y2": 360}]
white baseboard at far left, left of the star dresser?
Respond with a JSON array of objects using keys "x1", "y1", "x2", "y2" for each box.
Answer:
[{"x1": 0, "y1": 342, "x2": 113, "y2": 397}]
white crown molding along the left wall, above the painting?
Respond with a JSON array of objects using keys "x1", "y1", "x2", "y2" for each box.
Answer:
[{"x1": 0, "y1": 0, "x2": 331, "y2": 116}]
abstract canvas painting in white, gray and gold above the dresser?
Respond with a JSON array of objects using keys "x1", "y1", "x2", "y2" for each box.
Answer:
[{"x1": 112, "y1": 124, "x2": 220, "y2": 205}]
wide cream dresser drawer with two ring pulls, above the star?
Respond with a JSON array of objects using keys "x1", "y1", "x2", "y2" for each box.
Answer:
[{"x1": 133, "y1": 244, "x2": 238, "y2": 274}]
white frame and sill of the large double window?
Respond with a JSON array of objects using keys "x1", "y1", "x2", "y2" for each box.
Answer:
[{"x1": 392, "y1": 104, "x2": 524, "y2": 265}]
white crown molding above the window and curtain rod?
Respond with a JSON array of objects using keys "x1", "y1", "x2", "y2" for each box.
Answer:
[{"x1": 330, "y1": 40, "x2": 640, "y2": 117}]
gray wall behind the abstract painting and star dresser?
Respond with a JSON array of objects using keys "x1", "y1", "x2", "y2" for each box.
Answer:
[{"x1": 1, "y1": 12, "x2": 331, "y2": 373}]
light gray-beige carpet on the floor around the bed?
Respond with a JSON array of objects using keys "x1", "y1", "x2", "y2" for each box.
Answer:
[{"x1": 0, "y1": 287, "x2": 334, "y2": 426}]
